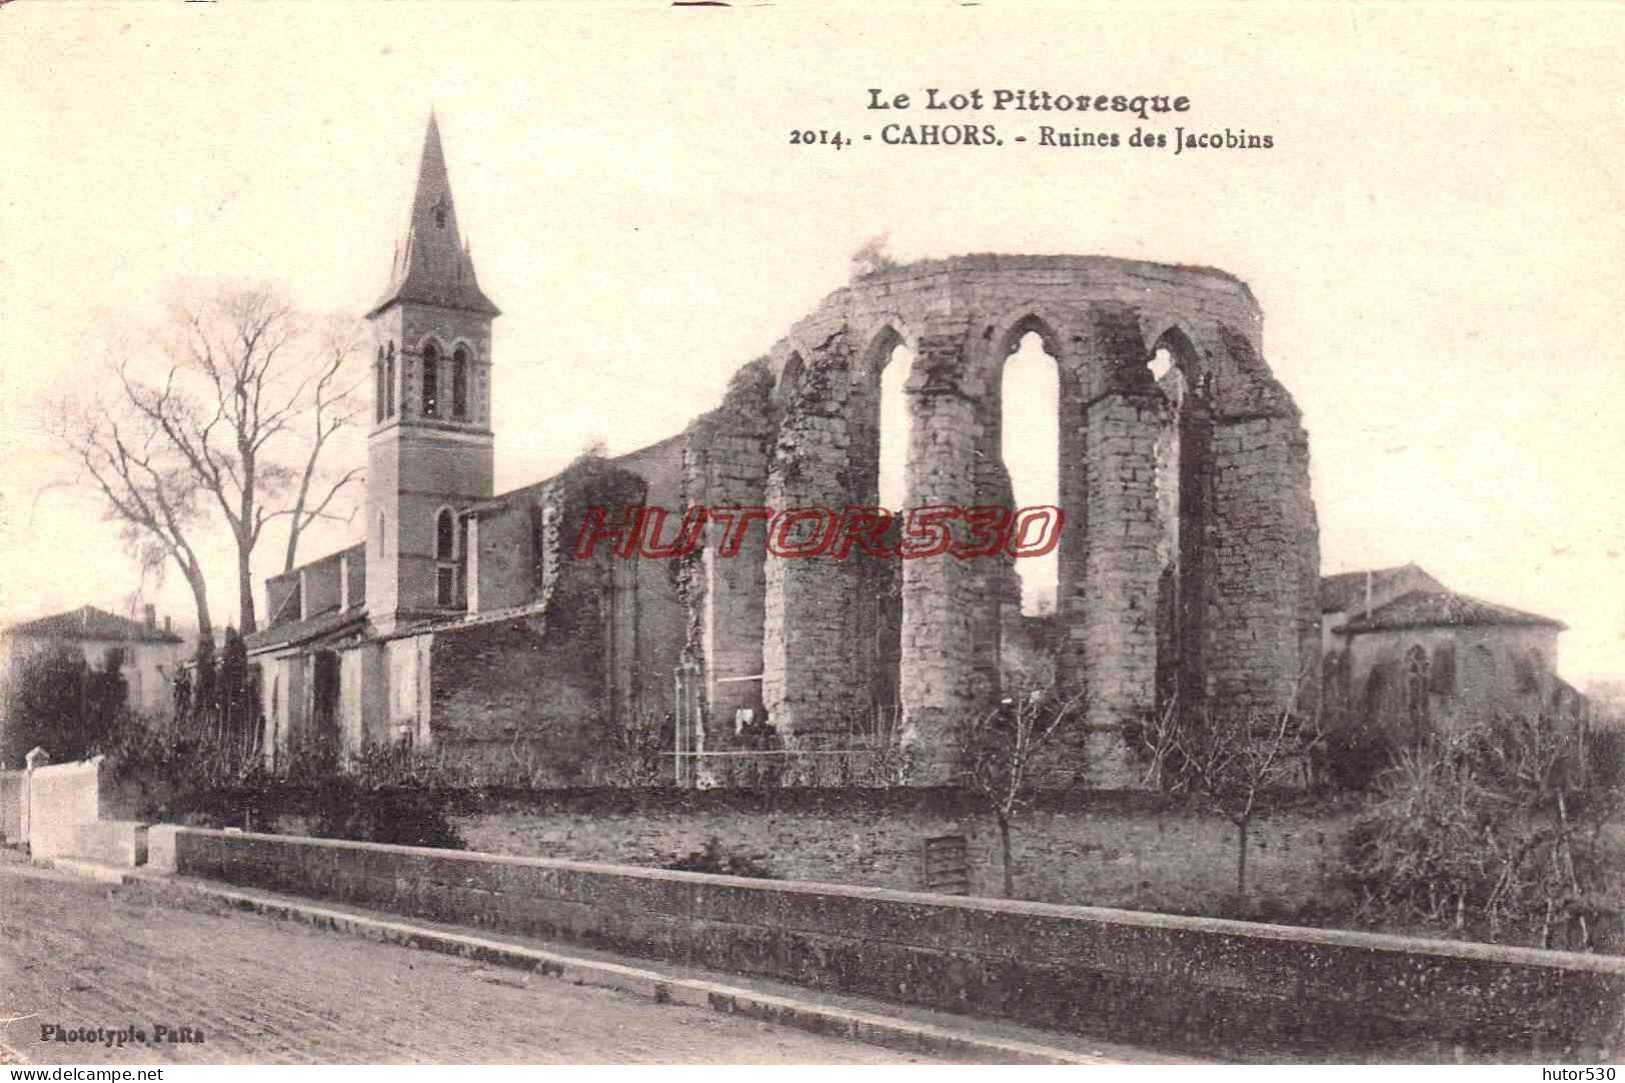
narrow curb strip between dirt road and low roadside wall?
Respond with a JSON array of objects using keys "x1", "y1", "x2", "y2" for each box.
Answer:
[{"x1": 123, "y1": 868, "x2": 1116, "y2": 1063}]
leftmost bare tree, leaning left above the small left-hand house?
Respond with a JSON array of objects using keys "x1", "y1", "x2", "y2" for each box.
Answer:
[{"x1": 47, "y1": 391, "x2": 215, "y2": 641}]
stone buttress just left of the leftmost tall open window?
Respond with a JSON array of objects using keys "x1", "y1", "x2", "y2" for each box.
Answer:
[{"x1": 762, "y1": 335, "x2": 869, "y2": 743}]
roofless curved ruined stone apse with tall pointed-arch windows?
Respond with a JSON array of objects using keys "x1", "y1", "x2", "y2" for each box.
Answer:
[{"x1": 681, "y1": 255, "x2": 1320, "y2": 782}]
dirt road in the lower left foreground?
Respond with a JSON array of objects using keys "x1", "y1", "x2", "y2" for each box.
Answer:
[{"x1": 0, "y1": 870, "x2": 928, "y2": 1063}]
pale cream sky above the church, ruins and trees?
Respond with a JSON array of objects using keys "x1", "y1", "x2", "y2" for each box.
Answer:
[{"x1": 0, "y1": 2, "x2": 1625, "y2": 680}]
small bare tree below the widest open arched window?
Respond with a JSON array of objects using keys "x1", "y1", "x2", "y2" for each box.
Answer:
[{"x1": 959, "y1": 689, "x2": 1082, "y2": 898}]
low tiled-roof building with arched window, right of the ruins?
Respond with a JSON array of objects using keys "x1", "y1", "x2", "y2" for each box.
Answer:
[{"x1": 1321, "y1": 564, "x2": 1586, "y2": 743}]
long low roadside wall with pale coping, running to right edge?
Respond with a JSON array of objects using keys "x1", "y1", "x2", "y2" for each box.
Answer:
[{"x1": 150, "y1": 826, "x2": 1625, "y2": 1060}]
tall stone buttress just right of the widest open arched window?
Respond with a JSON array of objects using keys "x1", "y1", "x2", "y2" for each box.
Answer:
[{"x1": 1082, "y1": 383, "x2": 1168, "y2": 785}]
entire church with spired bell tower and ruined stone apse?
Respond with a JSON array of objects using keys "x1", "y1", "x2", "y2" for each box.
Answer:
[{"x1": 250, "y1": 113, "x2": 1320, "y2": 782}]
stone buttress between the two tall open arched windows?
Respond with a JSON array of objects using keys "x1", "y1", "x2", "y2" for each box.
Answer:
[{"x1": 900, "y1": 335, "x2": 982, "y2": 785}]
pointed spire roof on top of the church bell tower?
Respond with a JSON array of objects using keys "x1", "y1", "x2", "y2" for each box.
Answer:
[{"x1": 369, "y1": 109, "x2": 499, "y2": 315}]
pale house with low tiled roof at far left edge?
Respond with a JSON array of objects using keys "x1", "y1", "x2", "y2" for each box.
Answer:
[{"x1": 0, "y1": 605, "x2": 185, "y2": 717}]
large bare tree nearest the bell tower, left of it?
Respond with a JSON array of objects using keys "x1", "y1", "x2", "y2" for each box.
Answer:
[{"x1": 119, "y1": 288, "x2": 361, "y2": 634}]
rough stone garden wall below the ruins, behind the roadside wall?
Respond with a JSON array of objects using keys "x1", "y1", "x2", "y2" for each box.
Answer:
[{"x1": 452, "y1": 792, "x2": 1355, "y2": 920}]
